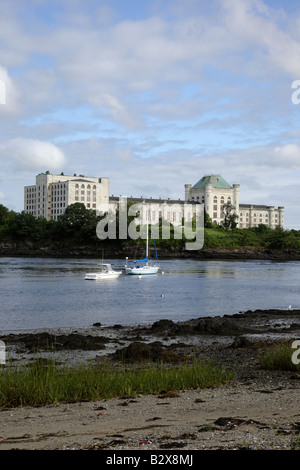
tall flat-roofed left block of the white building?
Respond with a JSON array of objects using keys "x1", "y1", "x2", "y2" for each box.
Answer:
[{"x1": 24, "y1": 173, "x2": 109, "y2": 220}]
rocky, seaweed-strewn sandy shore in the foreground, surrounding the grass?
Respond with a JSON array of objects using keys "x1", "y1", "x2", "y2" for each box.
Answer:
[{"x1": 0, "y1": 310, "x2": 300, "y2": 451}]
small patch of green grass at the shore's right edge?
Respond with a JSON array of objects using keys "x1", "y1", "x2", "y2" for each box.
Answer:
[{"x1": 259, "y1": 342, "x2": 300, "y2": 371}]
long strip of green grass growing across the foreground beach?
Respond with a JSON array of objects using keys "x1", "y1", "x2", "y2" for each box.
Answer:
[{"x1": 0, "y1": 360, "x2": 233, "y2": 408}]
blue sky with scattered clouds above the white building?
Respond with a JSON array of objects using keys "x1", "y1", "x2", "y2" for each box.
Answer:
[{"x1": 0, "y1": 0, "x2": 300, "y2": 230}]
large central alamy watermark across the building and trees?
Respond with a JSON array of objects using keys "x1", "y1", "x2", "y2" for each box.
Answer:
[{"x1": 96, "y1": 197, "x2": 204, "y2": 250}]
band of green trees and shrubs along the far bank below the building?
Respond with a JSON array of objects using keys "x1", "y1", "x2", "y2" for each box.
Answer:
[{"x1": 0, "y1": 201, "x2": 300, "y2": 251}]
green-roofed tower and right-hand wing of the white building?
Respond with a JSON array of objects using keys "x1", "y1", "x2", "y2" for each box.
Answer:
[{"x1": 185, "y1": 175, "x2": 284, "y2": 228}]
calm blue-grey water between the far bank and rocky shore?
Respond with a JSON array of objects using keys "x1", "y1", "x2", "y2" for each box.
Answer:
[{"x1": 0, "y1": 258, "x2": 300, "y2": 332}]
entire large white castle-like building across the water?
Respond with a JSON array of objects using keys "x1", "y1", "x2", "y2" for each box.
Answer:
[{"x1": 24, "y1": 173, "x2": 284, "y2": 228}]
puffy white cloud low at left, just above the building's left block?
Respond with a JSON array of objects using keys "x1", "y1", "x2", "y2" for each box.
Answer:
[{"x1": 0, "y1": 138, "x2": 65, "y2": 171}]
